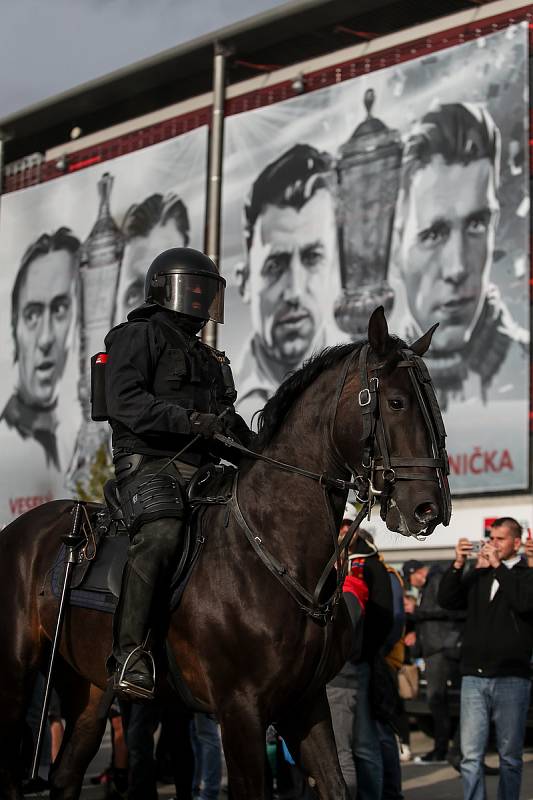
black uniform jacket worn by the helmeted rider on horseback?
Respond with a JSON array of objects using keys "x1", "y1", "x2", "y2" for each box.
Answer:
[{"x1": 105, "y1": 306, "x2": 250, "y2": 465}]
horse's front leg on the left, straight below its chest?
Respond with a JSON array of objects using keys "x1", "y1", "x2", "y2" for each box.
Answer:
[{"x1": 217, "y1": 695, "x2": 266, "y2": 800}]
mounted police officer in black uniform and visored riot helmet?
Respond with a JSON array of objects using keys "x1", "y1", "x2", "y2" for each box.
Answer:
[{"x1": 105, "y1": 247, "x2": 251, "y2": 699}]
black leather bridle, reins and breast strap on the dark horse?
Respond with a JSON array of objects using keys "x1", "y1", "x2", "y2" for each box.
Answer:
[{"x1": 214, "y1": 344, "x2": 451, "y2": 624}]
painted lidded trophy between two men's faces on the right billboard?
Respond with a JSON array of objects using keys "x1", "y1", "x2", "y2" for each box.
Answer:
[{"x1": 334, "y1": 89, "x2": 402, "y2": 337}]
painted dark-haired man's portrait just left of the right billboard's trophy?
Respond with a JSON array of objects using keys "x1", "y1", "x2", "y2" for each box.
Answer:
[{"x1": 236, "y1": 144, "x2": 338, "y2": 422}]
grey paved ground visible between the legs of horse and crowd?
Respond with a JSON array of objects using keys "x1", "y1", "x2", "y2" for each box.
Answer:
[{"x1": 26, "y1": 733, "x2": 533, "y2": 800}]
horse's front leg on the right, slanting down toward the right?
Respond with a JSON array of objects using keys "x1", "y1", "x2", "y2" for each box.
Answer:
[{"x1": 276, "y1": 689, "x2": 350, "y2": 800}]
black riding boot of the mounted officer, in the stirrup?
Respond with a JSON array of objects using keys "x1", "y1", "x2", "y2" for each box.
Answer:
[{"x1": 113, "y1": 564, "x2": 155, "y2": 700}]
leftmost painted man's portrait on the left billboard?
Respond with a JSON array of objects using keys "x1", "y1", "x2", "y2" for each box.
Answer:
[{"x1": 0, "y1": 227, "x2": 80, "y2": 470}]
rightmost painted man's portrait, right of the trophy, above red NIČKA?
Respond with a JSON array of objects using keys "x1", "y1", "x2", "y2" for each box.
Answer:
[{"x1": 395, "y1": 103, "x2": 529, "y2": 408}]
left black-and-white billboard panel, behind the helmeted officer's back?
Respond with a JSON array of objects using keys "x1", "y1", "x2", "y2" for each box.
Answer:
[{"x1": 0, "y1": 127, "x2": 207, "y2": 524}]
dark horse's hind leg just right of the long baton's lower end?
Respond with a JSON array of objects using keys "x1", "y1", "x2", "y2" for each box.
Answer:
[{"x1": 50, "y1": 665, "x2": 107, "y2": 800}]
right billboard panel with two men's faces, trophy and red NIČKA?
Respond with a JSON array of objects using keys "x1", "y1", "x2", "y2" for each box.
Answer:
[{"x1": 220, "y1": 23, "x2": 529, "y2": 494}]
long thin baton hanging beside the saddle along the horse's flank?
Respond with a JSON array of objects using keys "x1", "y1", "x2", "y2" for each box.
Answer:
[{"x1": 30, "y1": 500, "x2": 83, "y2": 780}]
